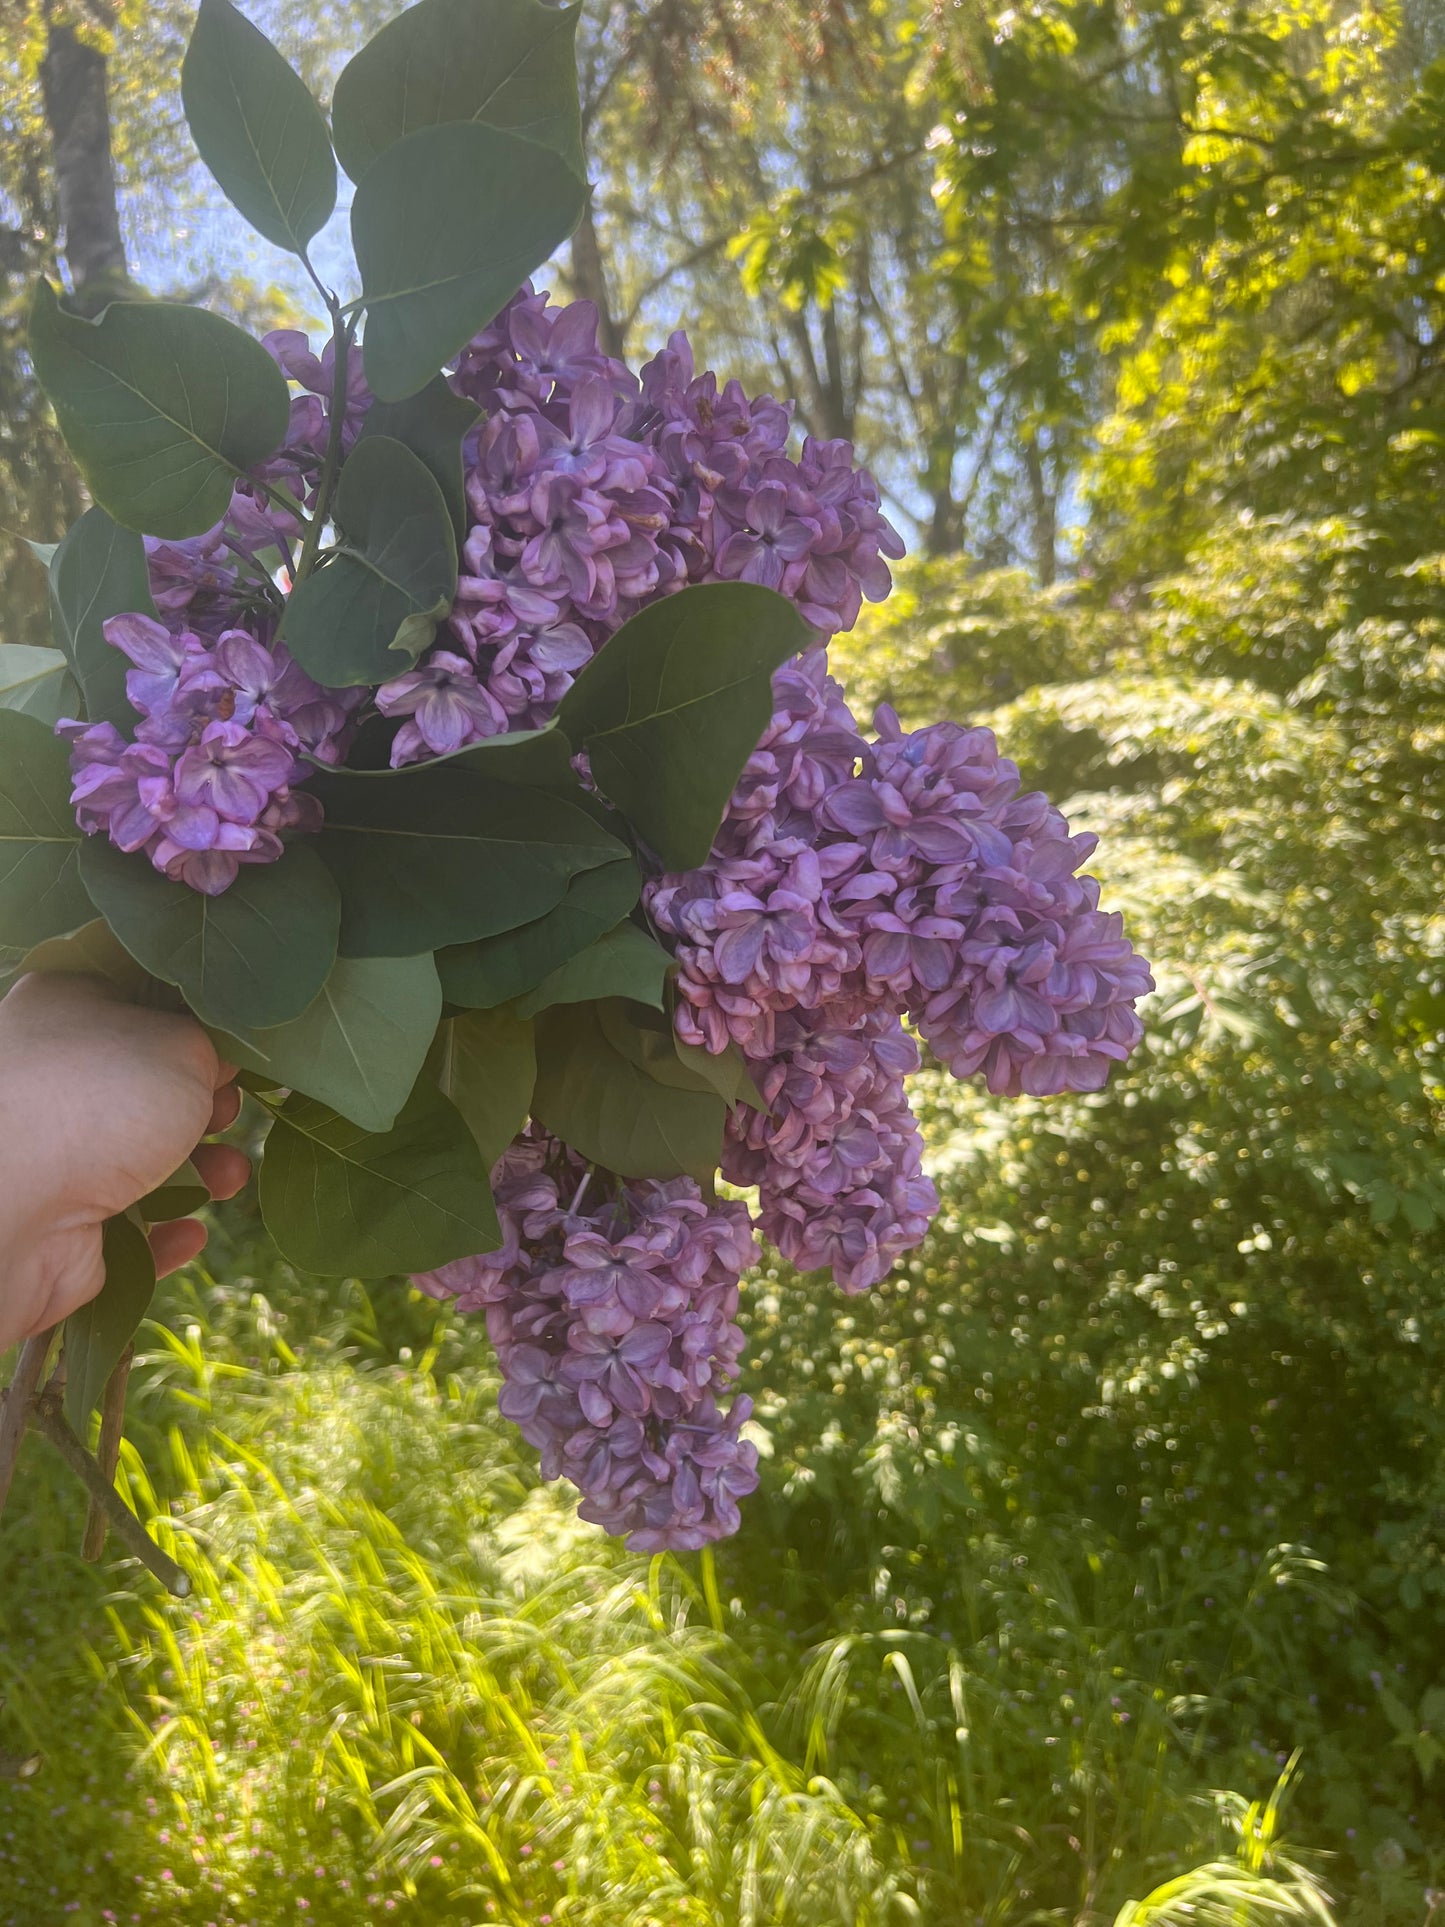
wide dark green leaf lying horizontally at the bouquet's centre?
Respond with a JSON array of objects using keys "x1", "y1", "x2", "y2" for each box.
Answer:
[{"x1": 312, "y1": 752, "x2": 624, "y2": 956}]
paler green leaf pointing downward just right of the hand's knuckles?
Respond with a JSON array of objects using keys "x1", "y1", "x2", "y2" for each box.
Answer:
[{"x1": 218, "y1": 956, "x2": 441, "y2": 1131}]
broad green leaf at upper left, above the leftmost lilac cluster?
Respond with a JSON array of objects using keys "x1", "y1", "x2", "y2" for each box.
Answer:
[{"x1": 29, "y1": 281, "x2": 291, "y2": 540}]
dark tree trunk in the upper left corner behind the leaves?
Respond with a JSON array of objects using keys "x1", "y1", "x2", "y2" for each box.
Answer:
[{"x1": 40, "y1": 27, "x2": 127, "y2": 314}]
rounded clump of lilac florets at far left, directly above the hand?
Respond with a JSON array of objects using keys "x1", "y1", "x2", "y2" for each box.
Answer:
[{"x1": 60, "y1": 615, "x2": 364, "y2": 896}]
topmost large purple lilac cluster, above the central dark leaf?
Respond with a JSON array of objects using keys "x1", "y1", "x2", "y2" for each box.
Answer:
[{"x1": 378, "y1": 287, "x2": 902, "y2": 765}]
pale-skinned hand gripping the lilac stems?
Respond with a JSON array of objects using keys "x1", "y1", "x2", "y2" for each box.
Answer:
[{"x1": 0, "y1": 975, "x2": 250, "y2": 1351}]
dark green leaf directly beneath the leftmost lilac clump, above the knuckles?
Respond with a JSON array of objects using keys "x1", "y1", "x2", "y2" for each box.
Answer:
[{"x1": 84, "y1": 836, "x2": 341, "y2": 1033}]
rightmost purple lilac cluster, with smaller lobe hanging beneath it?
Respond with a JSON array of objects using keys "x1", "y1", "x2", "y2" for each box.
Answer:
[{"x1": 645, "y1": 649, "x2": 1152, "y2": 1291}]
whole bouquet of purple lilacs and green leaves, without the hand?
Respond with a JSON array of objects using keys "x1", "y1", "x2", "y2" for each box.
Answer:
[{"x1": 0, "y1": 0, "x2": 1150, "y2": 1549}]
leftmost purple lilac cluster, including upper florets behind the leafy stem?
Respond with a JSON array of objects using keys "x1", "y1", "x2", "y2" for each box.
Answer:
[{"x1": 60, "y1": 330, "x2": 370, "y2": 896}]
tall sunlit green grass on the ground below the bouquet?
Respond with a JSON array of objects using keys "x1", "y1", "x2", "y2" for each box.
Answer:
[{"x1": 0, "y1": 1248, "x2": 1331, "y2": 1927}]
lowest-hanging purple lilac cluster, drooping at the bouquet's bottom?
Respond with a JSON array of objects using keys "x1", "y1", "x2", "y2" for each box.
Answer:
[{"x1": 414, "y1": 1127, "x2": 757, "y2": 1551}]
